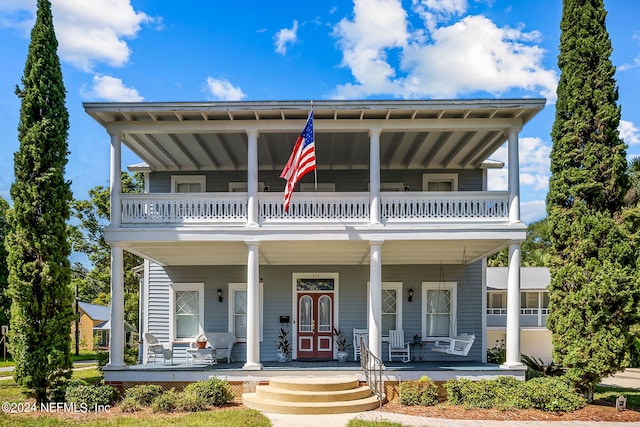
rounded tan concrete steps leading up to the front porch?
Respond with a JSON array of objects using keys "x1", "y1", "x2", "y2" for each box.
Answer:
[{"x1": 242, "y1": 376, "x2": 380, "y2": 414}]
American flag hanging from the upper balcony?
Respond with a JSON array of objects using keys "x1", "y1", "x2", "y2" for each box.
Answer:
[{"x1": 280, "y1": 111, "x2": 316, "y2": 212}]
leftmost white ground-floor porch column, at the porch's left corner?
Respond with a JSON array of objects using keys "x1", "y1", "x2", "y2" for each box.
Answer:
[{"x1": 107, "y1": 244, "x2": 126, "y2": 368}]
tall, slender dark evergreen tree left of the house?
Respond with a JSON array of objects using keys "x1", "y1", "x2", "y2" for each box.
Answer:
[{"x1": 7, "y1": 0, "x2": 74, "y2": 402}]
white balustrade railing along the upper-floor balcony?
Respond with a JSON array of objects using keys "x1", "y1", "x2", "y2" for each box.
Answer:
[{"x1": 121, "y1": 192, "x2": 509, "y2": 224}]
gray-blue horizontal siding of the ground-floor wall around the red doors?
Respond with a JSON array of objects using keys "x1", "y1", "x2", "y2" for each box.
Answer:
[{"x1": 148, "y1": 262, "x2": 483, "y2": 361}]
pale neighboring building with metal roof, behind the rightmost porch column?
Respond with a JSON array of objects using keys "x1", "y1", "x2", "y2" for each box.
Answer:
[{"x1": 487, "y1": 267, "x2": 553, "y2": 363}]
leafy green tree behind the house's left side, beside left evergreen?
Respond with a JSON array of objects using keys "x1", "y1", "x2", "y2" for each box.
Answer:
[{"x1": 71, "y1": 172, "x2": 144, "y2": 325}]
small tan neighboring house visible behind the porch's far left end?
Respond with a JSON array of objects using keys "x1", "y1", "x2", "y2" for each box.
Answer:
[{"x1": 71, "y1": 301, "x2": 136, "y2": 350}]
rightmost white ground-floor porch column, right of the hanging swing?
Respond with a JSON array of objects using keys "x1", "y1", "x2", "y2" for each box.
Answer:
[{"x1": 500, "y1": 242, "x2": 524, "y2": 369}]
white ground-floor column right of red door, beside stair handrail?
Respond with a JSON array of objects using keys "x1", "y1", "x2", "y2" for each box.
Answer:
[{"x1": 367, "y1": 241, "x2": 382, "y2": 359}]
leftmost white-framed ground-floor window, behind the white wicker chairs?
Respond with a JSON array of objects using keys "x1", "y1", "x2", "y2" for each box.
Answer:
[{"x1": 169, "y1": 283, "x2": 204, "y2": 341}]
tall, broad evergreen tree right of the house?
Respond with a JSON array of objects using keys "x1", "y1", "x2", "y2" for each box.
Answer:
[{"x1": 547, "y1": 0, "x2": 640, "y2": 398}]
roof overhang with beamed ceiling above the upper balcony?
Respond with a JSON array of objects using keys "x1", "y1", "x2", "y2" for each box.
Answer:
[{"x1": 84, "y1": 99, "x2": 545, "y2": 171}]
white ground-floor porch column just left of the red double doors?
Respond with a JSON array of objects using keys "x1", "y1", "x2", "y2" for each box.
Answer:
[{"x1": 242, "y1": 242, "x2": 262, "y2": 371}]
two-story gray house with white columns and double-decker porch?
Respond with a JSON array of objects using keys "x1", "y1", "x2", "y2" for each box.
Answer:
[{"x1": 84, "y1": 99, "x2": 545, "y2": 375}]
